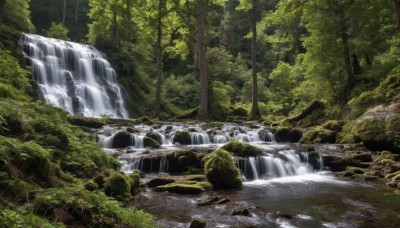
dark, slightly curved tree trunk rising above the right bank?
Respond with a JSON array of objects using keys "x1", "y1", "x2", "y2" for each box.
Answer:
[{"x1": 339, "y1": 6, "x2": 354, "y2": 102}]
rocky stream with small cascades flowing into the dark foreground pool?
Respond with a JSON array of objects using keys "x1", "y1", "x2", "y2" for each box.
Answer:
[{"x1": 98, "y1": 123, "x2": 400, "y2": 227}]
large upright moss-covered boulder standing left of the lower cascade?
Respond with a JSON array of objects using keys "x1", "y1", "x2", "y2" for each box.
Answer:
[{"x1": 204, "y1": 149, "x2": 242, "y2": 188}]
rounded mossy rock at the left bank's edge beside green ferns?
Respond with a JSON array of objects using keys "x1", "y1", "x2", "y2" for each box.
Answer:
[{"x1": 104, "y1": 172, "x2": 131, "y2": 198}]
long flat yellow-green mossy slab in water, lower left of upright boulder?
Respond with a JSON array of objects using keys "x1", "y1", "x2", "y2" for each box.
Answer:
[{"x1": 154, "y1": 182, "x2": 212, "y2": 195}]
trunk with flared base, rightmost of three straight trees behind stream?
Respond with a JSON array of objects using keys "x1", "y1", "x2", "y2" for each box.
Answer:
[{"x1": 250, "y1": 0, "x2": 261, "y2": 120}]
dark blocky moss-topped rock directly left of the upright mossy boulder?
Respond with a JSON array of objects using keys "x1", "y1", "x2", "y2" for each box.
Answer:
[{"x1": 167, "y1": 151, "x2": 203, "y2": 173}]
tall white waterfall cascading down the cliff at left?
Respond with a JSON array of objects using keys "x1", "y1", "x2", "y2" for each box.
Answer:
[{"x1": 21, "y1": 34, "x2": 128, "y2": 118}]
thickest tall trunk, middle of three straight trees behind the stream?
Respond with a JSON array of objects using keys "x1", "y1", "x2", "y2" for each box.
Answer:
[{"x1": 196, "y1": 0, "x2": 210, "y2": 119}]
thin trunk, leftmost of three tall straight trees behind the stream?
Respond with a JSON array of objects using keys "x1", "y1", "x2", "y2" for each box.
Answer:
[{"x1": 154, "y1": 0, "x2": 163, "y2": 118}]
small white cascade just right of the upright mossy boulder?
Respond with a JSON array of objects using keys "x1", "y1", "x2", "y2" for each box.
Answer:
[{"x1": 235, "y1": 150, "x2": 313, "y2": 180}]
